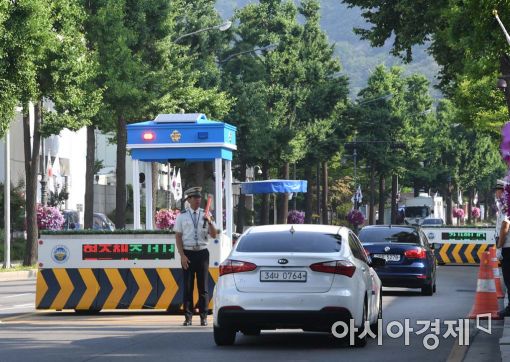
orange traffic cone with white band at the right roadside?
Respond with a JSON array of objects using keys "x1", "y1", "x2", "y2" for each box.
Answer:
[{"x1": 468, "y1": 251, "x2": 500, "y2": 319}]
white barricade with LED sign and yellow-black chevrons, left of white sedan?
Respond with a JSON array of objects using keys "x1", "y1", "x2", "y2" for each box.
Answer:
[{"x1": 35, "y1": 233, "x2": 232, "y2": 312}]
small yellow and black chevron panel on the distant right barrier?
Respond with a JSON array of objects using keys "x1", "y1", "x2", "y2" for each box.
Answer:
[{"x1": 435, "y1": 243, "x2": 491, "y2": 264}]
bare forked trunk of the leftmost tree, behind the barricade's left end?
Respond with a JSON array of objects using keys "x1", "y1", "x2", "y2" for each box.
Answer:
[{"x1": 23, "y1": 102, "x2": 42, "y2": 266}]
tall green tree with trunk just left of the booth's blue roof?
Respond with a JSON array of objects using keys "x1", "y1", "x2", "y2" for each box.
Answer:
[{"x1": 83, "y1": 0, "x2": 169, "y2": 228}]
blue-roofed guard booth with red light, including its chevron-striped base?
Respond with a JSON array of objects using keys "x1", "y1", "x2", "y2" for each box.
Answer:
[{"x1": 36, "y1": 114, "x2": 236, "y2": 312}]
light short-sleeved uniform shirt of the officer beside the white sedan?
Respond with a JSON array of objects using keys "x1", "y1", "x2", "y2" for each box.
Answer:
[{"x1": 174, "y1": 208, "x2": 216, "y2": 250}]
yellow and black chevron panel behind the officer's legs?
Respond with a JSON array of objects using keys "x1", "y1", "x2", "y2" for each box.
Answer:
[{"x1": 36, "y1": 268, "x2": 218, "y2": 311}]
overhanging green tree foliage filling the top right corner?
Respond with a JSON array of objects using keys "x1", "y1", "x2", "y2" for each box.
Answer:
[{"x1": 344, "y1": 0, "x2": 510, "y2": 132}]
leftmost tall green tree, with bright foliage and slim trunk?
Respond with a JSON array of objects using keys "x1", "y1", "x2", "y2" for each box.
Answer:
[{"x1": 0, "y1": 0, "x2": 100, "y2": 265}]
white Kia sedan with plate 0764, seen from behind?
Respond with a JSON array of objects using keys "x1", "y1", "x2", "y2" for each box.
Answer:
[{"x1": 214, "y1": 225, "x2": 385, "y2": 346}]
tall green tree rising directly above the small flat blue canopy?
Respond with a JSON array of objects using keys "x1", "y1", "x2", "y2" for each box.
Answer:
[{"x1": 231, "y1": 0, "x2": 336, "y2": 223}]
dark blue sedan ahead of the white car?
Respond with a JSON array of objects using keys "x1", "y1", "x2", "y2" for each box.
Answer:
[{"x1": 359, "y1": 225, "x2": 436, "y2": 295}]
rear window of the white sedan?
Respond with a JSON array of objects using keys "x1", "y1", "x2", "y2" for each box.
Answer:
[{"x1": 236, "y1": 231, "x2": 342, "y2": 253}]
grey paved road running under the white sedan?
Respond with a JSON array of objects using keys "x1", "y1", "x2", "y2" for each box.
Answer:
[{"x1": 0, "y1": 266, "x2": 500, "y2": 362}]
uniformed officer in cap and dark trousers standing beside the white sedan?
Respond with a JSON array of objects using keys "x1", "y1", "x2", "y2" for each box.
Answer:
[{"x1": 174, "y1": 187, "x2": 216, "y2": 326}]
